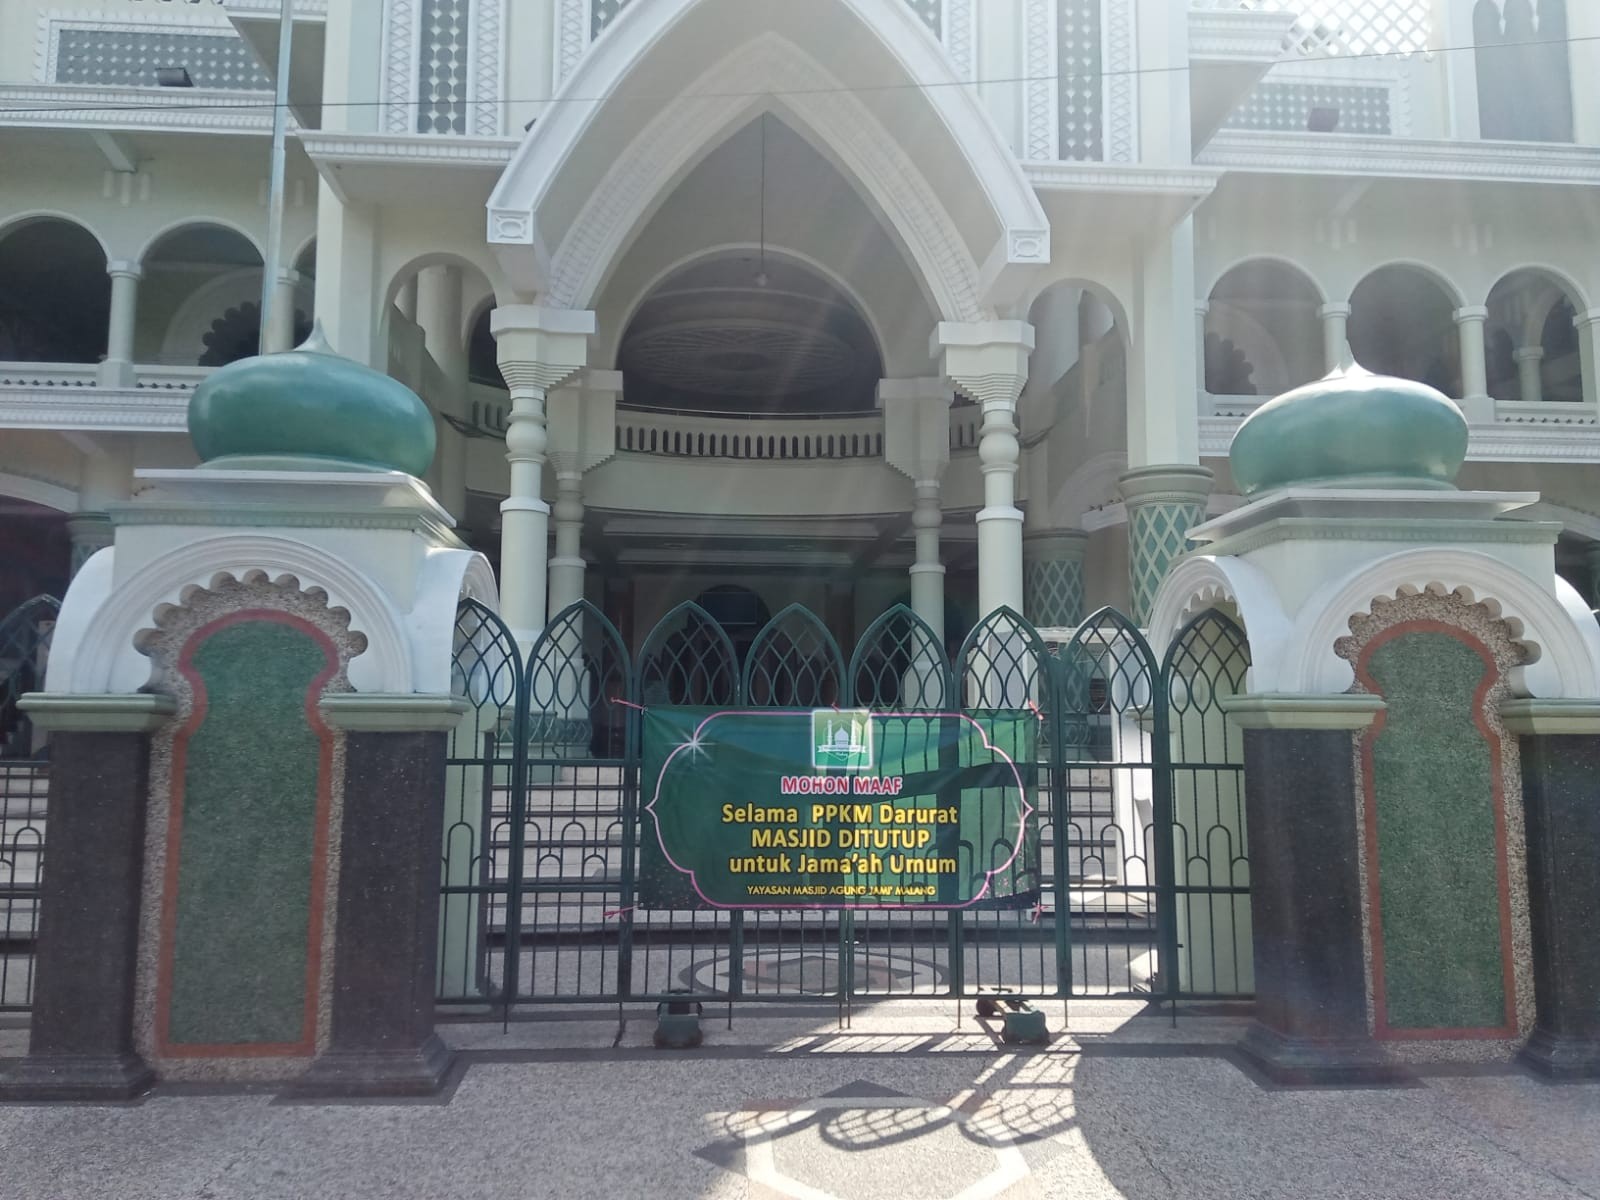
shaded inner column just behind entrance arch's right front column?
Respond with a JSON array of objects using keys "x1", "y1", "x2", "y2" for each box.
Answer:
[{"x1": 878, "y1": 378, "x2": 954, "y2": 646}]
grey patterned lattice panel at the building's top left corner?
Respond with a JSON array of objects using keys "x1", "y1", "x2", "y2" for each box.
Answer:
[{"x1": 54, "y1": 27, "x2": 272, "y2": 90}]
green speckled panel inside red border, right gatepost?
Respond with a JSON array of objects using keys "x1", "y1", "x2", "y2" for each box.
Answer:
[{"x1": 1368, "y1": 630, "x2": 1506, "y2": 1029}]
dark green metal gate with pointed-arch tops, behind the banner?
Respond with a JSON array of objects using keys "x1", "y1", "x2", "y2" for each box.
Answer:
[{"x1": 437, "y1": 600, "x2": 1253, "y2": 1011}]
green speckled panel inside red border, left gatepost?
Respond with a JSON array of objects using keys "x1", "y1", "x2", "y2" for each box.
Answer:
[{"x1": 168, "y1": 621, "x2": 330, "y2": 1045}]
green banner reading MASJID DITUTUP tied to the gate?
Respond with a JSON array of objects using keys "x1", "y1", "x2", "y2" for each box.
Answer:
[{"x1": 638, "y1": 706, "x2": 1038, "y2": 909}]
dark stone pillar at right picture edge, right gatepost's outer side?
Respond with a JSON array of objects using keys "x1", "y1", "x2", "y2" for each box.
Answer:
[{"x1": 1501, "y1": 699, "x2": 1600, "y2": 1078}]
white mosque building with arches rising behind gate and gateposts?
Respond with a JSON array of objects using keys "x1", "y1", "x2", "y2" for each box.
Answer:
[{"x1": 0, "y1": 0, "x2": 1600, "y2": 659}]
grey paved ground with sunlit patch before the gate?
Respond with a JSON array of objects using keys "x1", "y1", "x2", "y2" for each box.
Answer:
[{"x1": 0, "y1": 1005, "x2": 1600, "y2": 1200}]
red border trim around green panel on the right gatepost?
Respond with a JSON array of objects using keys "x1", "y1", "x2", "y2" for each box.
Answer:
[{"x1": 1355, "y1": 621, "x2": 1517, "y2": 1042}]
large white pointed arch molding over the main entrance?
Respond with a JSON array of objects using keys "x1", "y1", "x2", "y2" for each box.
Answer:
[{"x1": 488, "y1": 0, "x2": 1050, "y2": 320}]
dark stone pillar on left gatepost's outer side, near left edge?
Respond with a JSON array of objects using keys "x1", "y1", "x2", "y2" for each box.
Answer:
[{"x1": 0, "y1": 693, "x2": 175, "y2": 1101}]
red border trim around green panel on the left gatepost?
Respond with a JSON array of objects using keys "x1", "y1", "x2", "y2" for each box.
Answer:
[{"x1": 155, "y1": 608, "x2": 339, "y2": 1058}]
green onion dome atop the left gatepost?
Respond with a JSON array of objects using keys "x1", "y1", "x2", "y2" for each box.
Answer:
[{"x1": 189, "y1": 326, "x2": 435, "y2": 475}]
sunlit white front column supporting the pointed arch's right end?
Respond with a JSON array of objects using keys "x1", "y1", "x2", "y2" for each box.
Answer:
[{"x1": 931, "y1": 322, "x2": 1034, "y2": 621}]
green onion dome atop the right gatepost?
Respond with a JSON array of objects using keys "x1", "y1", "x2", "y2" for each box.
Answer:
[{"x1": 1229, "y1": 363, "x2": 1467, "y2": 496}]
